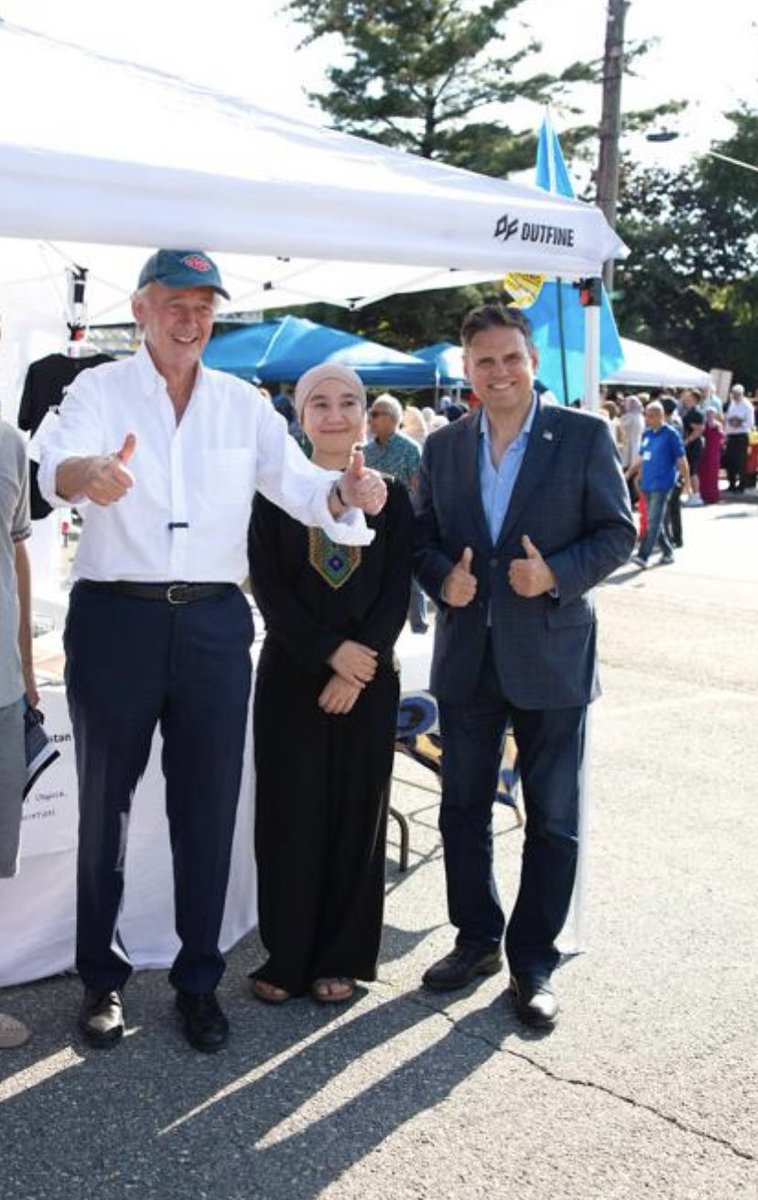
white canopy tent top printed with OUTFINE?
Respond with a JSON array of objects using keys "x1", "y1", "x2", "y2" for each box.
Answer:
[{"x1": 0, "y1": 19, "x2": 624, "y2": 393}]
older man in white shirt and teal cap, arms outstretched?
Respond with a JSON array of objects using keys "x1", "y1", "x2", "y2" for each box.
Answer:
[{"x1": 40, "y1": 250, "x2": 386, "y2": 1051}]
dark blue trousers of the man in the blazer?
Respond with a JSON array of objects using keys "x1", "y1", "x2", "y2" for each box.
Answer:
[{"x1": 439, "y1": 646, "x2": 586, "y2": 978}]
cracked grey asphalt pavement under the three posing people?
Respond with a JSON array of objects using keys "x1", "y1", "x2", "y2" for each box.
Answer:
[{"x1": 0, "y1": 493, "x2": 758, "y2": 1200}]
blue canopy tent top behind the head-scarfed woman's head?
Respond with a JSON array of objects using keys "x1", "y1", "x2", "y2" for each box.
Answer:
[{"x1": 203, "y1": 317, "x2": 435, "y2": 388}]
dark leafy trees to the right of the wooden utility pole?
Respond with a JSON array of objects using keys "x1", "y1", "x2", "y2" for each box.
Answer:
[{"x1": 614, "y1": 108, "x2": 758, "y2": 386}]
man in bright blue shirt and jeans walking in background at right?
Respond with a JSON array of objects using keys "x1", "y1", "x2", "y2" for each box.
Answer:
[{"x1": 632, "y1": 400, "x2": 691, "y2": 570}]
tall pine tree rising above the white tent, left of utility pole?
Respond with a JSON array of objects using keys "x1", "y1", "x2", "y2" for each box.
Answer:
[{"x1": 281, "y1": 0, "x2": 597, "y2": 176}]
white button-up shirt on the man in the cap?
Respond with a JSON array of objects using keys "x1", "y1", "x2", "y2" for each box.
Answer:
[{"x1": 38, "y1": 346, "x2": 373, "y2": 583}]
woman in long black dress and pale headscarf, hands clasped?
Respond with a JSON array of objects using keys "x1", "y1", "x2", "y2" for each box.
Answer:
[{"x1": 249, "y1": 364, "x2": 413, "y2": 1003}]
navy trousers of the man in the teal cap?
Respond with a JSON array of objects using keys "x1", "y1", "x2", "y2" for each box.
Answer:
[{"x1": 64, "y1": 581, "x2": 253, "y2": 994}]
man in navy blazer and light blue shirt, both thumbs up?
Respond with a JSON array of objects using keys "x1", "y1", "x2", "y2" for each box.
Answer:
[{"x1": 415, "y1": 305, "x2": 634, "y2": 1026}]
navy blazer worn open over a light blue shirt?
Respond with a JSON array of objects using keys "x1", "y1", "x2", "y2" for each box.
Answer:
[{"x1": 414, "y1": 401, "x2": 634, "y2": 709}]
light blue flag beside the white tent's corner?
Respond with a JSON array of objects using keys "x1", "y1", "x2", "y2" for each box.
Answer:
[{"x1": 523, "y1": 110, "x2": 624, "y2": 404}]
